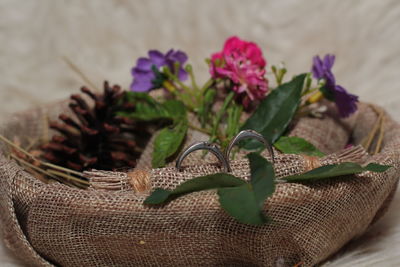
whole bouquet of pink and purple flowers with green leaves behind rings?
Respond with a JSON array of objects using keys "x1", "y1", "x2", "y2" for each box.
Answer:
[{"x1": 121, "y1": 36, "x2": 358, "y2": 170}]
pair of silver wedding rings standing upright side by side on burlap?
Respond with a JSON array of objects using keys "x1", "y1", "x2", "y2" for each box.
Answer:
[{"x1": 176, "y1": 130, "x2": 274, "y2": 172}]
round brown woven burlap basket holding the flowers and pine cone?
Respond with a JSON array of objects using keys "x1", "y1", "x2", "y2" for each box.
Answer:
[{"x1": 0, "y1": 101, "x2": 400, "y2": 266}]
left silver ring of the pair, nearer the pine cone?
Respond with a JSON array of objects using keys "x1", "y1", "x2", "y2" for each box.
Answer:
[{"x1": 176, "y1": 142, "x2": 231, "y2": 172}]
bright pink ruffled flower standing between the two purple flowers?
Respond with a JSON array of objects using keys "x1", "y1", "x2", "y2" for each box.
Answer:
[{"x1": 210, "y1": 36, "x2": 268, "y2": 107}]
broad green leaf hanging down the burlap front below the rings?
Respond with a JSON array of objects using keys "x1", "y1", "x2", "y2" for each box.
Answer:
[{"x1": 218, "y1": 184, "x2": 268, "y2": 225}]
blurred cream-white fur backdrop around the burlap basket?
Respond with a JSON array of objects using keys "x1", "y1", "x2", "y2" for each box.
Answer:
[{"x1": 0, "y1": 0, "x2": 400, "y2": 266}]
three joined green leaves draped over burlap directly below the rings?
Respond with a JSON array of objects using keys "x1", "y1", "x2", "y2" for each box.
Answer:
[{"x1": 144, "y1": 153, "x2": 275, "y2": 225}]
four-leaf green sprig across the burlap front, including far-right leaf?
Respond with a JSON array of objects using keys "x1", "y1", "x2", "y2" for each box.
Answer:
[{"x1": 144, "y1": 153, "x2": 391, "y2": 225}]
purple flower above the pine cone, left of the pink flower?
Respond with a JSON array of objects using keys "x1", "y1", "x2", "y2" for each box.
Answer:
[{"x1": 131, "y1": 49, "x2": 188, "y2": 92}]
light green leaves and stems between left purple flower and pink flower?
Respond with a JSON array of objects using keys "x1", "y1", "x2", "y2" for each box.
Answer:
[{"x1": 118, "y1": 68, "x2": 243, "y2": 168}]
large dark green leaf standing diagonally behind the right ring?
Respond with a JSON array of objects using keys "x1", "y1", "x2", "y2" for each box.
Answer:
[{"x1": 241, "y1": 74, "x2": 306, "y2": 149}]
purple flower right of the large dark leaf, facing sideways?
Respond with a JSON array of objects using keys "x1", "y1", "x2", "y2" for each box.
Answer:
[{"x1": 311, "y1": 54, "x2": 358, "y2": 118}]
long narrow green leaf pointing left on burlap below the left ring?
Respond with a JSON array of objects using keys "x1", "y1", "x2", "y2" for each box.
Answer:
[{"x1": 144, "y1": 173, "x2": 246, "y2": 204}]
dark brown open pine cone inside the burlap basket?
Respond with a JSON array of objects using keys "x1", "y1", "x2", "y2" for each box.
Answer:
[{"x1": 42, "y1": 81, "x2": 151, "y2": 171}]
